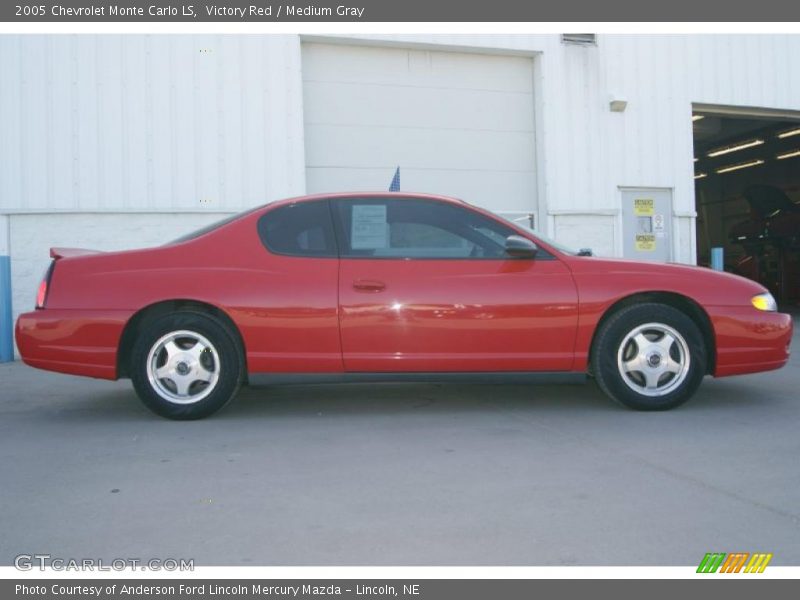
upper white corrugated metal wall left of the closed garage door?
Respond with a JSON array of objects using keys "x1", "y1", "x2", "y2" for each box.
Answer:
[{"x1": 0, "y1": 35, "x2": 304, "y2": 212}]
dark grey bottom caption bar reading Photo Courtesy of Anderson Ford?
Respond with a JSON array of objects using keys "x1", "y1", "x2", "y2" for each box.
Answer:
[{"x1": 0, "y1": 580, "x2": 797, "y2": 600}]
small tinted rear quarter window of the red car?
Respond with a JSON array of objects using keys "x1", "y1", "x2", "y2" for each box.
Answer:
[{"x1": 258, "y1": 200, "x2": 338, "y2": 257}]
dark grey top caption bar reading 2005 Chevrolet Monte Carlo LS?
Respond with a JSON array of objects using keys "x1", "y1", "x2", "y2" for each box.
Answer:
[{"x1": 0, "y1": 0, "x2": 800, "y2": 22}]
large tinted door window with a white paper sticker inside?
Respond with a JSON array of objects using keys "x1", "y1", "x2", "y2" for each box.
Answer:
[{"x1": 335, "y1": 198, "x2": 514, "y2": 259}]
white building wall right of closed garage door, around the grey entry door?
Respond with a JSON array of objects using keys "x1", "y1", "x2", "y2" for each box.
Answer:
[{"x1": 342, "y1": 35, "x2": 800, "y2": 263}]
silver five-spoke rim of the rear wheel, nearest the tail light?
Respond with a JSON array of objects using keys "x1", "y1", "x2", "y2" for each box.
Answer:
[{"x1": 147, "y1": 330, "x2": 221, "y2": 404}]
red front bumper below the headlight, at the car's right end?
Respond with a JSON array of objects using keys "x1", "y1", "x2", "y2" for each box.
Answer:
[{"x1": 711, "y1": 307, "x2": 793, "y2": 377}]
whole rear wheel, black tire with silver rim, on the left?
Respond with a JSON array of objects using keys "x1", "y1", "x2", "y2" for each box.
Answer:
[{"x1": 129, "y1": 311, "x2": 244, "y2": 420}]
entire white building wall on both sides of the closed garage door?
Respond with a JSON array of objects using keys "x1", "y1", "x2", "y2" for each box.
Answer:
[{"x1": 0, "y1": 35, "x2": 800, "y2": 342}]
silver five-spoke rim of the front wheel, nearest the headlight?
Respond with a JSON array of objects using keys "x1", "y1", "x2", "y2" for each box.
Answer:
[{"x1": 617, "y1": 323, "x2": 691, "y2": 397}]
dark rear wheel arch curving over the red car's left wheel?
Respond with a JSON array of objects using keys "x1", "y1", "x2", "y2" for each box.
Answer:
[{"x1": 117, "y1": 298, "x2": 248, "y2": 380}]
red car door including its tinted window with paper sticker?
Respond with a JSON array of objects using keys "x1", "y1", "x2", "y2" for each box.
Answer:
[{"x1": 332, "y1": 196, "x2": 577, "y2": 372}]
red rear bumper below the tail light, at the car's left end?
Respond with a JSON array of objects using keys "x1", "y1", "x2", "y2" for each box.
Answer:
[{"x1": 15, "y1": 309, "x2": 133, "y2": 379}]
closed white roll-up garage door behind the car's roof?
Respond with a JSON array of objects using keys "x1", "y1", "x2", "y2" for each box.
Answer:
[{"x1": 303, "y1": 43, "x2": 536, "y2": 211}]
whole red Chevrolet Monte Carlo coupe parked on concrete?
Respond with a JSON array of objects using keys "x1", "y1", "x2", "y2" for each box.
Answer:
[{"x1": 16, "y1": 192, "x2": 792, "y2": 419}]
